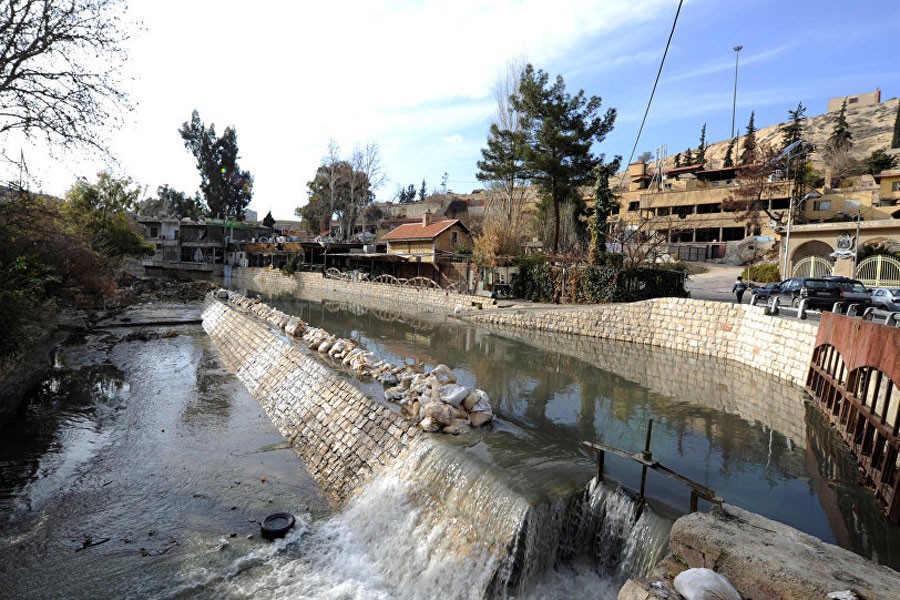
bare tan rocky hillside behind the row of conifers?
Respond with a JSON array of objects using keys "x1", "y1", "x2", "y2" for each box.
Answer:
[{"x1": 666, "y1": 98, "x2": 900, "y2": 170}]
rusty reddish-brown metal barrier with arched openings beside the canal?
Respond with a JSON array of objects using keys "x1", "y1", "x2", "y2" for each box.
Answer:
[{"x1": 806, "y1": 313, "x2": 900, "y2": 522}]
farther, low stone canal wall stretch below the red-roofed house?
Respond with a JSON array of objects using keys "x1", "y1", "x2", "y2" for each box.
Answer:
[{"x1": 224, "y1": 267, "x2": 497, "y2": 314}]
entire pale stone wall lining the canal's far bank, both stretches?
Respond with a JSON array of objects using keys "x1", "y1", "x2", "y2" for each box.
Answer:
[{"x1": 231, "y1": 268, "x2": 817, "y2": 385}]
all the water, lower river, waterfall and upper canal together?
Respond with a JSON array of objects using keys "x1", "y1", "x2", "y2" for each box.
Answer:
[{"x1": 0, "y1": 301, "x2": 900, "y2": 599}]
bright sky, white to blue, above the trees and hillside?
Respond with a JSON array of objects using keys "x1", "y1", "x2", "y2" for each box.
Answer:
[{"x1": 7, "y1": 0, "x2": 900, "y2": 219}]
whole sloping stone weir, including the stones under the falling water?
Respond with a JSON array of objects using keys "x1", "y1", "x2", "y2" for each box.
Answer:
[{"x1": 203, "y1": 295, "x2": 531, "y2": 596}]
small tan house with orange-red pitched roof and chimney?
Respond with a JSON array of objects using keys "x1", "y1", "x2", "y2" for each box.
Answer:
[{"x1": 380, "y1": 211, "x2": 472, "y2": 263}]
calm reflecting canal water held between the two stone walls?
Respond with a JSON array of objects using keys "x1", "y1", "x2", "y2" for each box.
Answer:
[{"x1": 251, "y1": 298, "x2": 900, "y2": 567}]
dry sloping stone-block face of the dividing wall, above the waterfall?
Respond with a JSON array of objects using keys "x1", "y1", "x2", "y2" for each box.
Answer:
[{"x1": 203, "y1": 296, "x2": 418, "y2": 504}]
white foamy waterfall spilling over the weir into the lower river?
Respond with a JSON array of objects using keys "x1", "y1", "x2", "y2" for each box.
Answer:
[{"x1": 173, "y1": 443, "x2": 668, "y2": 600}]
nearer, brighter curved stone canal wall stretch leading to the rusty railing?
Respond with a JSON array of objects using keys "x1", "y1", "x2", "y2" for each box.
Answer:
[{"x1": 466, "y1": 298, "x2": 817, "y2": 385}]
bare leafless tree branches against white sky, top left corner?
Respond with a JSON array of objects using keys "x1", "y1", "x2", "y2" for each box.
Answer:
[{"x1": 0, "y1": 0, "x2": 129, "y2": 157}]
